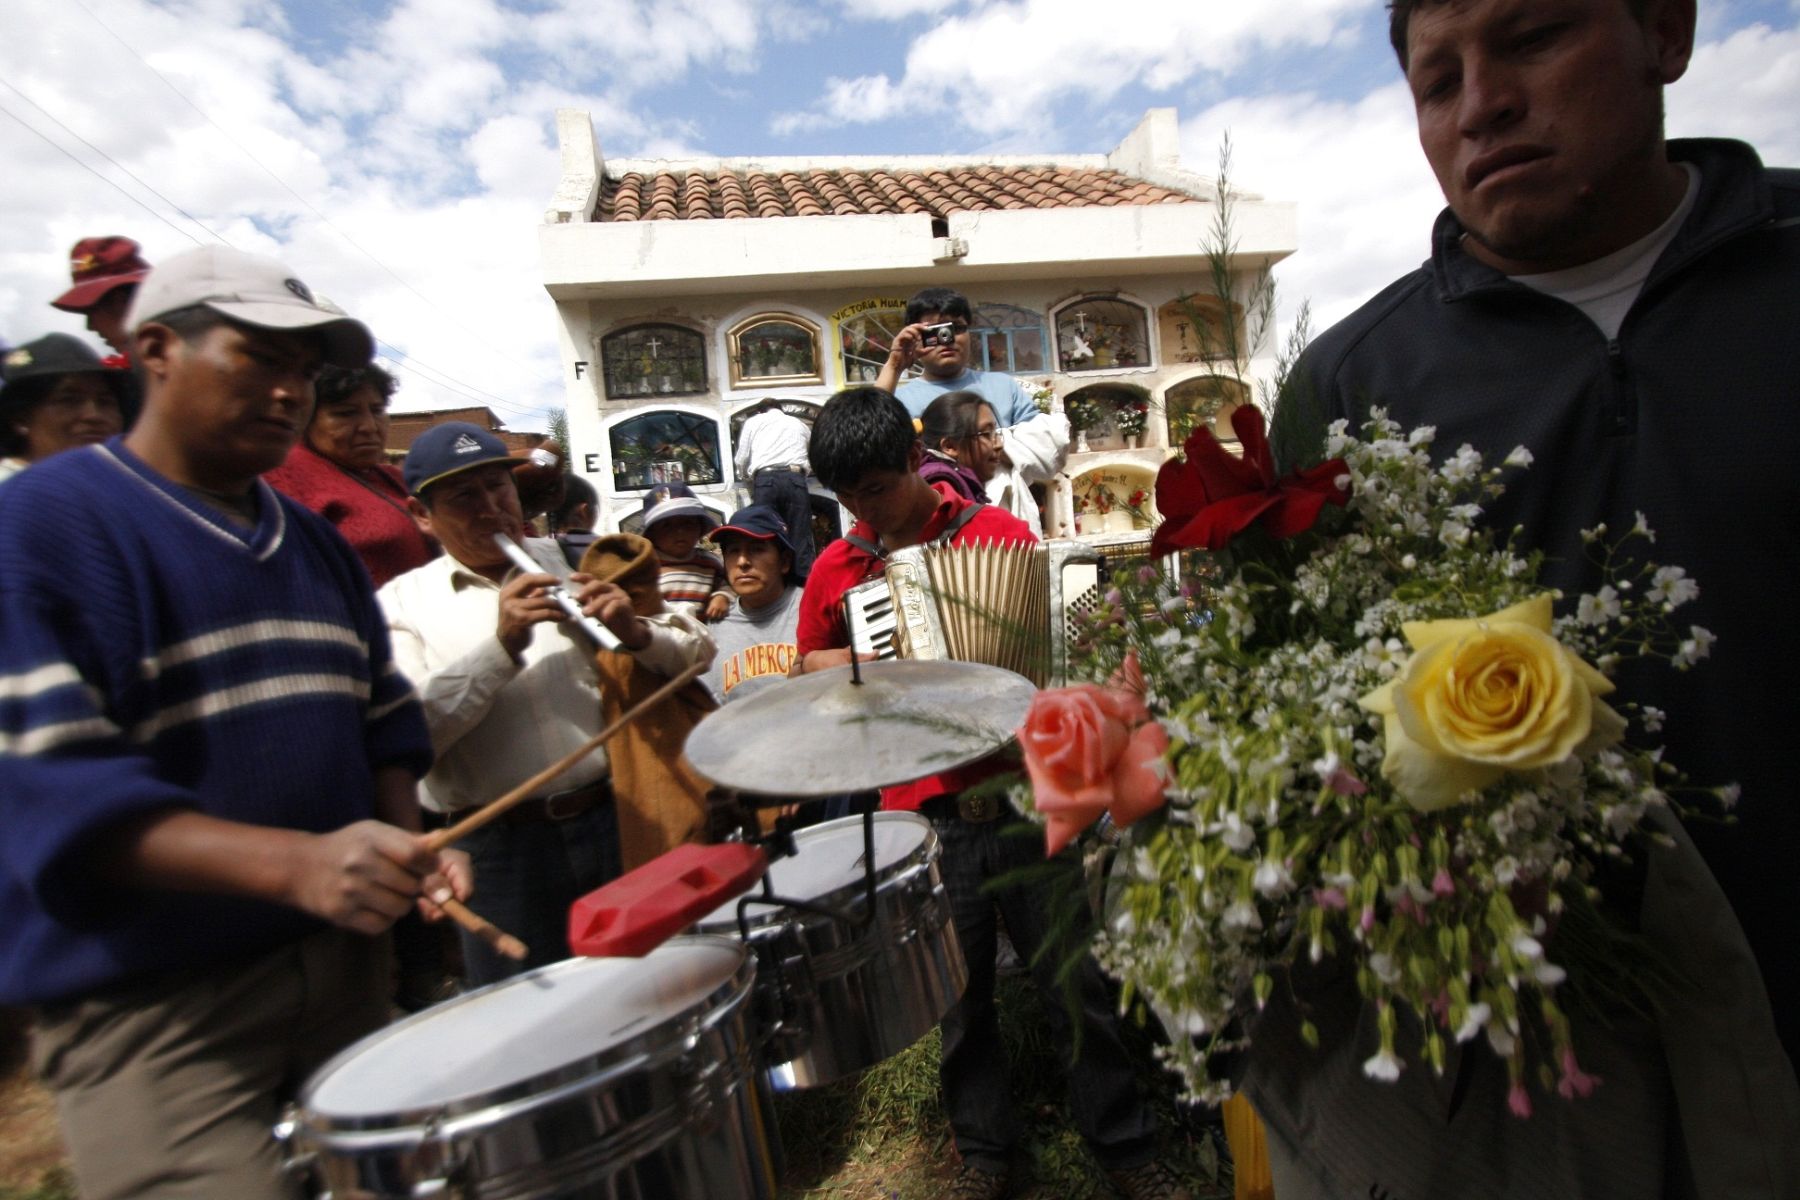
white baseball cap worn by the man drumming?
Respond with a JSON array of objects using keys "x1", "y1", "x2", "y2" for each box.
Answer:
[{"x1": 126, "y1": 246, "x2": 374, "y2": 367}]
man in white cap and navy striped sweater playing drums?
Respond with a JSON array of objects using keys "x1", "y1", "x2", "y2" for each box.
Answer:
[{"x1": 0, "y1": 246, "x2": 468, "y2": 1200}]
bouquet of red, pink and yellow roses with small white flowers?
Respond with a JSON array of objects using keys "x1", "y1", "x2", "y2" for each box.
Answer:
[{"x1": 1019, "y1": 405, "x2": 1733, "y2": 1115}]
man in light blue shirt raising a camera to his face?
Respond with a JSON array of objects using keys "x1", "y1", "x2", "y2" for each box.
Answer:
[{"x1": 875, "y1": 288, "x2": 1069, "y2": 536}]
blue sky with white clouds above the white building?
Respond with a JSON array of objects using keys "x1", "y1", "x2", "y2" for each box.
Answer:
[{"x1": 0, "y1": 0, "x2": 1800, "y2": 430}]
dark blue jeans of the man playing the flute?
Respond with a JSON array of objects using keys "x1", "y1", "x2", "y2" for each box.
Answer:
[{"x1": 457, "y1": 799, "x2": 619, "y2": 988}]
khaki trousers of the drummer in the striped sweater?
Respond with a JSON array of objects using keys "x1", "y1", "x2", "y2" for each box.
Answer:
[{"x1": 32, "y1": 930, "x2": 389, "y2": 1200}]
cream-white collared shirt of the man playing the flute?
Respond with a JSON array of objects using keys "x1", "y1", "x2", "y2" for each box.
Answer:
[{"x1": 376, "y1": 538, "x2": 713, "y2": 811}]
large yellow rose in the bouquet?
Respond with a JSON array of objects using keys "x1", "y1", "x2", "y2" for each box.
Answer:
[{"x1": 1361, "y1": 596, "x2": 1625, "y2": 811}]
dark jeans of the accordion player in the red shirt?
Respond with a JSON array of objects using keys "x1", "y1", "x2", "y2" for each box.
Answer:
[{"x1": 922, "y1": 797, "x2": 1156, "y2": 1171}]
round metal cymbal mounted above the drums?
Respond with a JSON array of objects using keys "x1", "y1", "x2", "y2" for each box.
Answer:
[{"x1": 688, "y1": 658, "x2": 1037, "y2": 797}]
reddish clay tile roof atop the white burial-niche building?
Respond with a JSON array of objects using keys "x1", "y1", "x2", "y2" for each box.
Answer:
[{"x1": 596, "y1": 166, "x2": 1195, "y2": 221}]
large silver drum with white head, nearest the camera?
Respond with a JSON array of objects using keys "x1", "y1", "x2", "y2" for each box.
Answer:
[{"x1": 277, "y1": 937, "x2": 776, "y2": 1200}]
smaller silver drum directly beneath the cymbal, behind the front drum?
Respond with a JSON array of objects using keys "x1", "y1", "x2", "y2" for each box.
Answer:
[{"x1": 698, "y1": 813, "x2": 968, "y2": 1090}]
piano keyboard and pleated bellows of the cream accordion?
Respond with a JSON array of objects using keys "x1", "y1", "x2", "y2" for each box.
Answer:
[{"x1": 844, "y1": 543, "x2": 1051, "y2": 687}]
